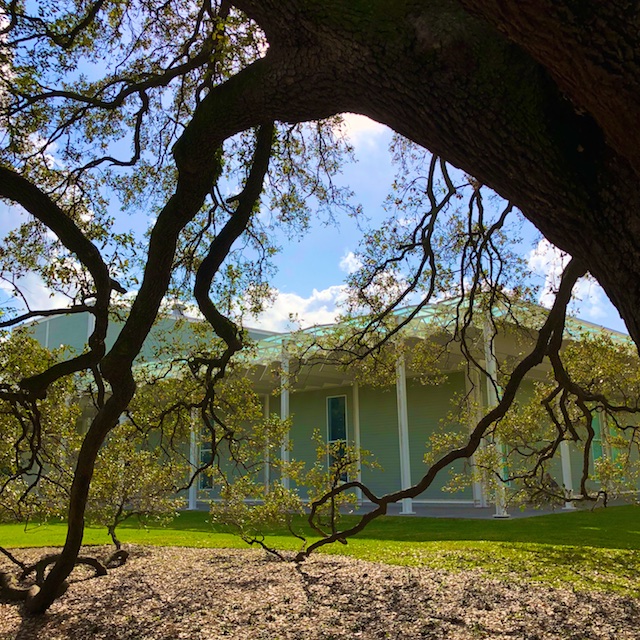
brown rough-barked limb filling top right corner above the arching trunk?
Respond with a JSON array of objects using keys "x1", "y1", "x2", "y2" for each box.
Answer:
[{"x1": 462, "y1": 0, "x2": 640, "y2": 180}]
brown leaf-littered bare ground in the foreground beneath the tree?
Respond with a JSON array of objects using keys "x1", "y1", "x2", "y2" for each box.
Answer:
[{"x1": 0, "y1": 547, "x2": 640, "y2": 640}]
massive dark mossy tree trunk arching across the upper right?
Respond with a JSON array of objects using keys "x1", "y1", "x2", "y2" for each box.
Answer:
[{"x1": 220, "y1": 0, "x2": 640, "y2": 344}]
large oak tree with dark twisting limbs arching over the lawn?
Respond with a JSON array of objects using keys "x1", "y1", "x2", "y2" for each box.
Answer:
[{"x1": 0, "y1": 0, "x2": 640, "y2": 612}]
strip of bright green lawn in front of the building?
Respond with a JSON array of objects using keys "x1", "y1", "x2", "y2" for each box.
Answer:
[{"x1": 0, "y1": 505, "x2": 640, "y2": 597}]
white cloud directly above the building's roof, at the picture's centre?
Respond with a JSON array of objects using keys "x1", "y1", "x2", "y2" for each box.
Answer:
[{"x1": 246, "y1": 285, "x2": 346, "y2": 331}]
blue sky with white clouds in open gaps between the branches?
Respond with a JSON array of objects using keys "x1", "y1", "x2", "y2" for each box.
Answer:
[{"x1": 0, "y1": 114, "x2": 625, "y2": 338}]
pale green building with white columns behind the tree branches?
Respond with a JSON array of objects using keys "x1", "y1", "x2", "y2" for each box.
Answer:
[{"x1": 30, "y1": 309, "x2": 624, "y2": 515}]
